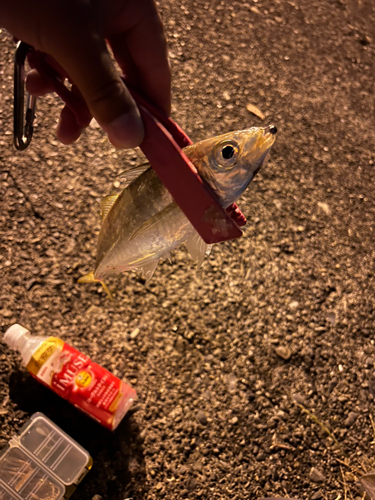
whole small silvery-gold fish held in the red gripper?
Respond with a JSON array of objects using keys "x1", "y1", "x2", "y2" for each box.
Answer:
[{"x1": 78, "y1": 125, "x2": 277, "y2": 297}]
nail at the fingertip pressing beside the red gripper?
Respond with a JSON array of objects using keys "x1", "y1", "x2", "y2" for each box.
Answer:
[{"x1": 101, "y1": 112, "x2": 144, "y2": 148}]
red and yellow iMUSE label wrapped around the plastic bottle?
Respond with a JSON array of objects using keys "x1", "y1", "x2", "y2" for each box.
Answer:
[{"x1": 27, "y1": 337, "x2": 136, "y2": 429}]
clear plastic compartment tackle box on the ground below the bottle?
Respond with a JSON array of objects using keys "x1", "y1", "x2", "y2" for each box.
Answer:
[{"x1": 0, "y1": 413, "x2": 92, "y2": 500}]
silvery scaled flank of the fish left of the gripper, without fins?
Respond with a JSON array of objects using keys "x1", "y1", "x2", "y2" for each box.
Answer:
[{"x1": 95, "y1": 168, "x2": 193, "y2": 279}]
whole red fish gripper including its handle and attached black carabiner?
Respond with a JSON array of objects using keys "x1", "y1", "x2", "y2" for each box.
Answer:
[{"x1": 14, "y1": 42, "x2": 246, "y2": 244}]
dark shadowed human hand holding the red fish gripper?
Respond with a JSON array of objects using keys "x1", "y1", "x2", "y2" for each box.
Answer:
[{"x1": 0, "y1": 0, "x2": 171, "y2": 148}]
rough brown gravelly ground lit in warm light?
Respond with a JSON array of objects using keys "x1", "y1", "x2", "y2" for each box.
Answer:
[{"x1": 0, "y1": 0, "x2": 375, "y2": 500}]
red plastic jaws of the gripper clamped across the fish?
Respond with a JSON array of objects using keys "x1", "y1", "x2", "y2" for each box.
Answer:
[{"x1": 128, "y1": 82, "x2": 246, "y2": 244}]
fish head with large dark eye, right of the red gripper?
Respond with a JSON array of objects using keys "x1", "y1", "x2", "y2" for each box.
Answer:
[{"x1": 186, "y1": 125, "x2": 277, "y2": 208}]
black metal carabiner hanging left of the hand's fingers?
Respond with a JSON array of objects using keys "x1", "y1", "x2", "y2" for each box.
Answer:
[{"x1": 13, "y1": 42, "x2": 36, "y2": 151}]
